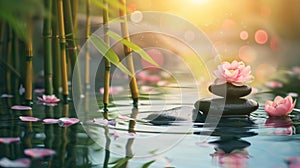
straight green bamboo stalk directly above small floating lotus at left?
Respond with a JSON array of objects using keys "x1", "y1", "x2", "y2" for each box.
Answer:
[{"x1": 43, "y1": 0, "x2": 53, "y2": 95}]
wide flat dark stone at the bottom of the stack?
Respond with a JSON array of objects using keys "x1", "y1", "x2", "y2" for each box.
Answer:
[{"x1": 194, "y1": 98, "x2": 258, "y2": 115}]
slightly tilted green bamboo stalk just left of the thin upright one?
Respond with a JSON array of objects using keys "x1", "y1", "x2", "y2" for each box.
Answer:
[{"x1": 63, "y1": 0, "x2": 81, "y2": 95}]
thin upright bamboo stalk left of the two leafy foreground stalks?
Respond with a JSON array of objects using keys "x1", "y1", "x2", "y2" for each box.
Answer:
[{"x1": 85, "y1": 0, "x2": 91, "y2": 90}]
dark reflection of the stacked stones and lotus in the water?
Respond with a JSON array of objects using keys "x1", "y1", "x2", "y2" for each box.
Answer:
[{"x1": 194, "y1": 115, "x2": 257, "y2": 168}]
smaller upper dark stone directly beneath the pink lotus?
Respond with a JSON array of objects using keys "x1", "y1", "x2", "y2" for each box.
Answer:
[{"x1": 208, "y1": 83, "x2": 252, "y2": 98}]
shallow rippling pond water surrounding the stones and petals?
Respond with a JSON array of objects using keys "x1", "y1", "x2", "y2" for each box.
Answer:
[{"x1": 0, "y1": 78, "x2": 300, "y2": 168}]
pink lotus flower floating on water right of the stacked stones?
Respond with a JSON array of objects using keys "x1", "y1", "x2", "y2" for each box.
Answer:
[{"x1": 264, "y1": 96, "x2": 296, "y2": 116}]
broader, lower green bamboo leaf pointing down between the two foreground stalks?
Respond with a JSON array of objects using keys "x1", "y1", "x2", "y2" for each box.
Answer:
[{"x1": 90, "y1": 34, "x2": 133, "y2": 76}]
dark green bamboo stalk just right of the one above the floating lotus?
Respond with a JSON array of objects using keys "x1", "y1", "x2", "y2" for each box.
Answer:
[{"x1": 51, "y1": 0, "x2": 62, "y2": 95}]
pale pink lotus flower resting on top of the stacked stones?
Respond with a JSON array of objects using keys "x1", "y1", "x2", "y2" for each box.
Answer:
[{"x1": 213, "y1": 61, "x2": 253, "y2": 86}]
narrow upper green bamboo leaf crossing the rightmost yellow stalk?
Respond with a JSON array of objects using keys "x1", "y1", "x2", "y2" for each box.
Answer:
[{"x1": 107, "y1": 31, "x2": 158, "y2": 67}]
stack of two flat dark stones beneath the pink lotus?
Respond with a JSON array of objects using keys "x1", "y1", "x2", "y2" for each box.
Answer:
[{"x1": 194, "y1": 82, "x2": 258, "y2": 115}]
